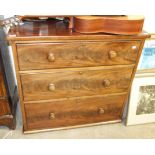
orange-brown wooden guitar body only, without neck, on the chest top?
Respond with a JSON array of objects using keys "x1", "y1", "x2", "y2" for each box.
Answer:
[{"x1": 73, "y1": 16, "x2": 144, "y2": 35}]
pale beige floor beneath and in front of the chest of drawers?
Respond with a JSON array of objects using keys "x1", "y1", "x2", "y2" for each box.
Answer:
[{"x1": 0, "y1": 103, "x2": 155, "y2": 139}]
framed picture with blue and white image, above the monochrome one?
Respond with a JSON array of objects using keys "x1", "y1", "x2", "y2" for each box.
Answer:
[{"x1": 138, "y1": 34, "x2": 155, "y2": 72}]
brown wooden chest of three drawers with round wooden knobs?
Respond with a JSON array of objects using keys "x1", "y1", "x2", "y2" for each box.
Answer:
[{"x1": 8, "y1": 21, "x2": 149, "y2": 133}]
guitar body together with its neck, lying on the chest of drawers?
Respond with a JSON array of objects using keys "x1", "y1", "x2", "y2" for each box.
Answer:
[{"x1": 13, "y1": 15, "x2": 144, "y2": 35}]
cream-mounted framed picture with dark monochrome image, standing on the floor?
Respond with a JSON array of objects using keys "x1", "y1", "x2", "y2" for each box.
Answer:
[{"x1": 126, "y1": 73, "x2": 155, "y2": 125}]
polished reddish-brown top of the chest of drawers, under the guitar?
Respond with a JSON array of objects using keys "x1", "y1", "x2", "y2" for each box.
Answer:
[{"x1": 7, "y1": 20, "x2": 150, "y2": 42}]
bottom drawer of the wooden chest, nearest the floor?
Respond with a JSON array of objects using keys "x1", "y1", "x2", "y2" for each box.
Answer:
[{"x1": 25, "y1": 94, "x2": 126, "y2": 130}]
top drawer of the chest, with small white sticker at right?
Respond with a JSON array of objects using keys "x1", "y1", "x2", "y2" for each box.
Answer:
[{"x1": 17, "y1": 41, "x2": 141, "y2": 70}]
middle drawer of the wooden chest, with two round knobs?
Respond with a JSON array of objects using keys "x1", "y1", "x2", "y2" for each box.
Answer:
[{"x1": 21, "y1": 65, "x2": 134, "y2": 101}]
